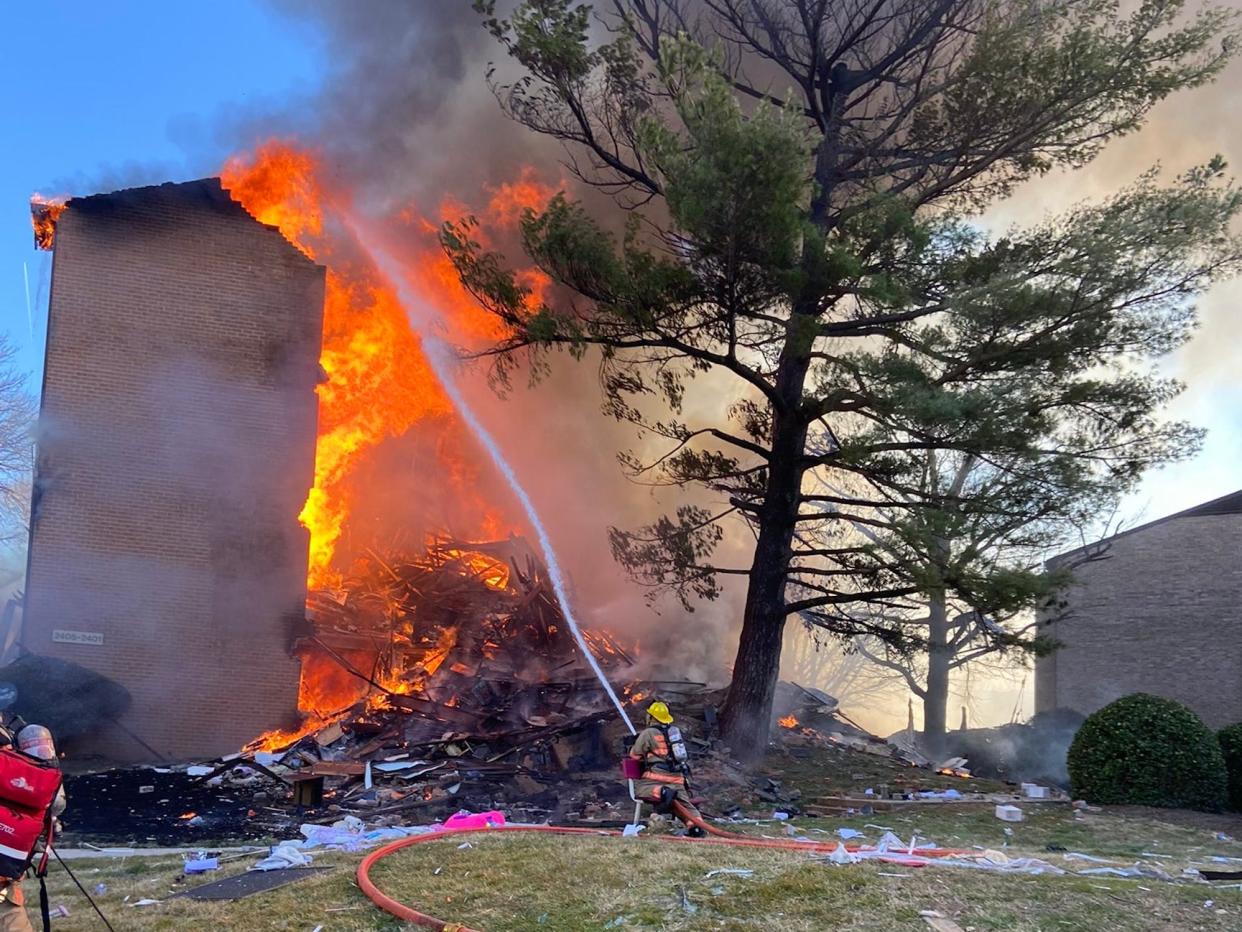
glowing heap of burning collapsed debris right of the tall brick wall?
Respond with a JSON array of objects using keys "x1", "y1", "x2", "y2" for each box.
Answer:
[{"x1": 248, "y1": 537, "x2": 633, "y2": 751}]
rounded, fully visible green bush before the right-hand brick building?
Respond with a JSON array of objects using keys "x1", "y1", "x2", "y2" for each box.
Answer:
[{"x1": 1068, "y1": 692, "x2": 1228, "y2": 811}]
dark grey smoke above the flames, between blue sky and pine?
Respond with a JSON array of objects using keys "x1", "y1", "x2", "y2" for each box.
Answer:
[{"x1": 257, "y1": 0, "x2": 558, "y2": 211}]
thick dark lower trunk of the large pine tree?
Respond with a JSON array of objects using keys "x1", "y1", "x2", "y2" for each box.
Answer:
[{"x1": 720, "y1": 340, "x2": 810, "y2": 759}]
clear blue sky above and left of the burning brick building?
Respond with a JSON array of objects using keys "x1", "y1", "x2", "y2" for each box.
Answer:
[{"x1": 0, "y1": 0, "x2": 323, "y2": 380}]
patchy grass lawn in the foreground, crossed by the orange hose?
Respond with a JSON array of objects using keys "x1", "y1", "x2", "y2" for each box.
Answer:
[{"x1": 36, "y1": 805, "x2": 1242, "y2": 932}]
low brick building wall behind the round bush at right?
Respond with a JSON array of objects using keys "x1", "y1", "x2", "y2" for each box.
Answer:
[{"x1": 1035, "y1": 491, "x2": 1242, "y2": 728}]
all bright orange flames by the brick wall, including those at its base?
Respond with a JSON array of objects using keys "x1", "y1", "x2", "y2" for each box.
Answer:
[{"x1": 221, "y1": 143, "x2": 553, "y2": 735}]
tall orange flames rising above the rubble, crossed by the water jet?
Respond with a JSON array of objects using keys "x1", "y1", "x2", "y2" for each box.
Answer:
[{"x1": 221, "y1": 143, "x2": 551, "y2": 589}]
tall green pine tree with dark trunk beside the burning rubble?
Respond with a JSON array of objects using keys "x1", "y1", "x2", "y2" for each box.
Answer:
[{"x1": 452, "y1": 0, "x2": 1238, "y2": 751}]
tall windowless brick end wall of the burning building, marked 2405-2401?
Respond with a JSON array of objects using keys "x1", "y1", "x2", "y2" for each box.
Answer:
[{"x1": 21, "y1": 178, "x2": 324, "y2": 761}]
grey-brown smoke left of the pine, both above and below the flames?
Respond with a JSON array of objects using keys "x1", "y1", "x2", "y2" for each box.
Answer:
[{"x1": 216, "y1": 0, "x2": 746, "y2": 681}]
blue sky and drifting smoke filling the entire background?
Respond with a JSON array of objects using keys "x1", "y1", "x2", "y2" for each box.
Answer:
[{"x1": 0, "y1": 0, "x2": 1242, "y2": 731}]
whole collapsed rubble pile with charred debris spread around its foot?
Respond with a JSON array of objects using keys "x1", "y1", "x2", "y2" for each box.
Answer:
[{"x1": 58, "y1": 538, "x2": 1038, "y2": 845}]
